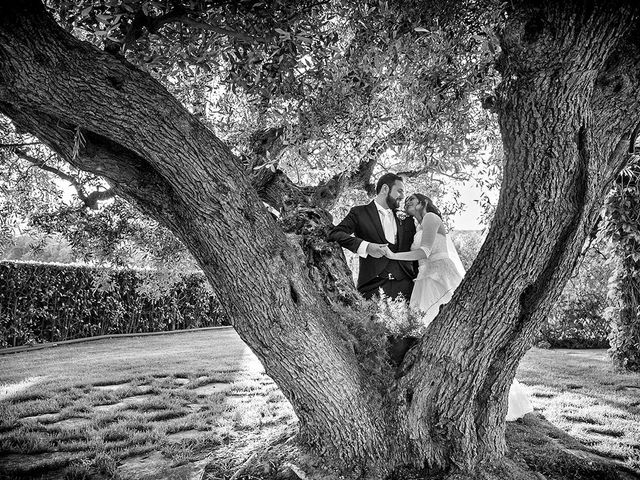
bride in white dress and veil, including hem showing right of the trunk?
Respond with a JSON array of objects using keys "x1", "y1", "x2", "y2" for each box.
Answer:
[{"x1": 385, "y1": 193, "x2": 533, "y2": 421}]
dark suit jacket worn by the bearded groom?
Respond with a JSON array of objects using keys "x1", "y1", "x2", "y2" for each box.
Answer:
[{"x1": 328, "y1": 202, "x2": 416, "y2": 291}]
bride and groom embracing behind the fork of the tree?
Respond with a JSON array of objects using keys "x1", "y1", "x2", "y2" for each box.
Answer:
[{"x1": 329, "y1": 173, "x2": 533, "y2": 420}]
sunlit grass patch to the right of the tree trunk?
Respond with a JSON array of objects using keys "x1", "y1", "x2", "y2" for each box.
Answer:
[{"x1": 518, "y1": 348, "x2": 640, "y2": 470}]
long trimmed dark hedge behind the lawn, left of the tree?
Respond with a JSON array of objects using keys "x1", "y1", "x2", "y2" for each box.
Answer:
[{"x1": 0, "y1": 261, "x2": 228, "y2": 348}]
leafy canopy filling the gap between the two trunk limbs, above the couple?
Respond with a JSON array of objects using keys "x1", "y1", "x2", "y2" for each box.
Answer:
[{"x1": 43, "y1": 0, "x2": 500, "y2": 191}]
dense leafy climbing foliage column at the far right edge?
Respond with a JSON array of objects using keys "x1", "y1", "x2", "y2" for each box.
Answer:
[{"x1": 605, "y1": 156, "x2": 640, "y2": 372}]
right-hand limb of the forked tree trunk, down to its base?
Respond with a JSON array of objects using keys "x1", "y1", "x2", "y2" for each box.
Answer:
[{"x1": 390, "y1": 2, "x2": 639, "y2": 469}]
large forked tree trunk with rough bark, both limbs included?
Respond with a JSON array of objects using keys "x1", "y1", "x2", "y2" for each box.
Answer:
[{"x1": 0, "y1": 2, "x2": 638, "y2": 478}]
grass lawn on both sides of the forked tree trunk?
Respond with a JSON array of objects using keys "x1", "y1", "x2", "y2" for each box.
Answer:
[{"x1": 0, "y1": 329, "x2": 640, "y2": 480}]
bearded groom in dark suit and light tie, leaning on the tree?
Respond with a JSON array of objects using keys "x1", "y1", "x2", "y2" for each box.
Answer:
[{"x1": 328, "y1": 173, "x2": 416, "y2": 300}]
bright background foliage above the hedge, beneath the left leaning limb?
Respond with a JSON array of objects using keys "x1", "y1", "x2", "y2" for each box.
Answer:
[{"x1": 0, "y1": 117, "x2": 197, "y2": 270}]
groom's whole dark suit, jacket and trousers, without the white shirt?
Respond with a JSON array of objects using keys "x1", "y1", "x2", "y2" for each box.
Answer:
[{"x1": 328, "y1": 202, "x2": 416, "y2": 299}]
